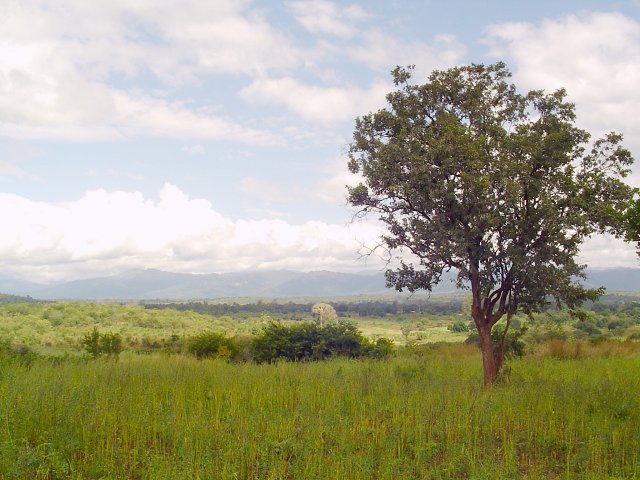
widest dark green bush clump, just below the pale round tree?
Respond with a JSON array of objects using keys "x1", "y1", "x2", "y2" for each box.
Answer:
[{"x1": 251, "y1": 322, "x2": 392, "y2": 363}]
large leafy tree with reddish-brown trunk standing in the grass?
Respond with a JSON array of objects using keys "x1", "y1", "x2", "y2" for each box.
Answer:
[{"x1": 348, "y1": 63, "x2": 633, "y2": 384}]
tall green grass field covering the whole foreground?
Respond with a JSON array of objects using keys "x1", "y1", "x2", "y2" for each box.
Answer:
[{"x1": 0, "y1": 347, "x2": 640, "y2": 479}]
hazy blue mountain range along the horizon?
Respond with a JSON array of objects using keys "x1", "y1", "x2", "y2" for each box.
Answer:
[{"x1": 0, "y1": 268, "x2": 640, "y2": 300}]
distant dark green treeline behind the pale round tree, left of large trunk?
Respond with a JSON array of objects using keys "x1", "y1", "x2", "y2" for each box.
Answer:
[{"x1": 143, "y1": 298, "x2": 463, "y2": 318}]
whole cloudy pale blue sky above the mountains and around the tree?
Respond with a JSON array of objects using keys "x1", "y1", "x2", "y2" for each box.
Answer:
[{"x1": 0, "y1": 0, "x2": 640, "y2": 282}]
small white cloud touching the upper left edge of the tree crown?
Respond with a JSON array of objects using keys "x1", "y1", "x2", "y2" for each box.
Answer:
[{"x1": 240, "y1": 77, "x2": 391, "y2": 124}]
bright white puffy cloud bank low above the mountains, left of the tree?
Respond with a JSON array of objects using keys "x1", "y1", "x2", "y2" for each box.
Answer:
[{"x1": 0, "y1": 184, "x2": 379, "y2": 280}]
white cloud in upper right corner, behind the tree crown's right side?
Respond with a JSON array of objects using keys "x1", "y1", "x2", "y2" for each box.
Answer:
[{"x1": 487, "y1": 12, "x2": 640, "y2": 169}]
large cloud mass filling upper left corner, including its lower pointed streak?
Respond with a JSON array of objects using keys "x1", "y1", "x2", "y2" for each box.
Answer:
[{"x1": 0, "y1": 0, "x2": 298, "y2": 143}]
